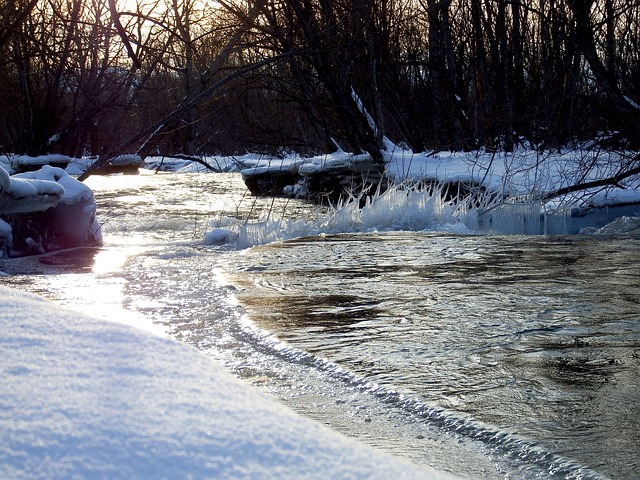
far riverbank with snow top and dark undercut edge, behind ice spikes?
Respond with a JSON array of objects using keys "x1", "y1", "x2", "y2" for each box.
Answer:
[{"x1": 146, "y1": 148, "x2": 640, "y2": 234}]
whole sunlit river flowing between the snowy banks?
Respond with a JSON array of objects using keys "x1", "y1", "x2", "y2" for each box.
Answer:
[{"x1": 0, "y1": 173, "x2": 640, "y2": 479}]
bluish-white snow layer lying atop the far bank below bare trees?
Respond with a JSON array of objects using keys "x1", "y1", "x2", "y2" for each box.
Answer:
[{"x1": 198, "y1": 146, "x2": 640, "y2": 208}]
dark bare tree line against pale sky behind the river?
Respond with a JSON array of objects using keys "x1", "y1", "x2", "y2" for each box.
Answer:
[{"x1": 0, "y1": 0, "x2": 640, "y2": 160}]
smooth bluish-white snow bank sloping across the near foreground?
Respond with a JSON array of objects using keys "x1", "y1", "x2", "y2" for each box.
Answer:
[{"x1": 0, "y1": 287, "x2": 450, "y2": 479}]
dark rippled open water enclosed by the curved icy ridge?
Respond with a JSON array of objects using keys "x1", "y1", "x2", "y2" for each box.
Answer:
[{"x1": 221, "y1": 232, "x2": 640, "y2": 478}]
